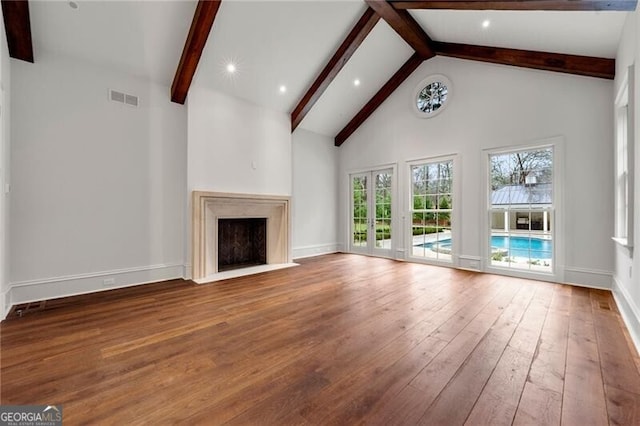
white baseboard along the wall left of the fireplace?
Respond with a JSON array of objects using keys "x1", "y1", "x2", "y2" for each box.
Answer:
[{"x1": 8, "y1": 264, "x2": 184, "y2": 305}]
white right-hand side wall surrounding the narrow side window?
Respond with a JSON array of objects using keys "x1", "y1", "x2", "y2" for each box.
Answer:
[{"x1": 610, "y1": 10, "x2": 640, "y2": 350}]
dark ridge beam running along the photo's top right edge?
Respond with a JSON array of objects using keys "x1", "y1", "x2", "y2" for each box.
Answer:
[{"x1": 390, "y1": 0, "x2": 638, "y2": 11}]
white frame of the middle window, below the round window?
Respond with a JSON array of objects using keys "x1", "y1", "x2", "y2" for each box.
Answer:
[{"x1": 403, "y1": 154, "x2": 462, "y2": 267}]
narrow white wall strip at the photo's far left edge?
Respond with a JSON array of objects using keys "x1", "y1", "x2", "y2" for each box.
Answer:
[{"x1": 0, "y1": 13, "x2": 11, "y2": 318}]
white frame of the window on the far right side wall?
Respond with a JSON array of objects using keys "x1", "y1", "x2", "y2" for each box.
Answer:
[{"x1": 613, "y1": 65, "x2": 635, "y2": 255}]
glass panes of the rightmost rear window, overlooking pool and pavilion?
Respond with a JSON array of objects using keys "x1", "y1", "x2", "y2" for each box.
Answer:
[{"x1": 488, "y1": 147, "x2": 555, "y2": 273}]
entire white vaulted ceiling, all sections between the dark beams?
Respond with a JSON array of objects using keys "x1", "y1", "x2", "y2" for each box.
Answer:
[{"x1": 29, "y1": 0, "x2": 627, "y2": 136}]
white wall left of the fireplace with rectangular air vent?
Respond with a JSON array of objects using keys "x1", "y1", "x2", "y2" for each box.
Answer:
[{"x1": 10, "y1": 51, "x2": 187, "y2": 303}]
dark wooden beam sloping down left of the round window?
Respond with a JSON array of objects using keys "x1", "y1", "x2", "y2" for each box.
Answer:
[{"x1": 335, "y1": 52, "x2": 424, "y2": 146}]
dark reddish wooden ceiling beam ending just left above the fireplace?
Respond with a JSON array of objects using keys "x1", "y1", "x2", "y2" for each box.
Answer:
[{"x1": 171, "y1": 0, "x2": 222, "y2": 104}]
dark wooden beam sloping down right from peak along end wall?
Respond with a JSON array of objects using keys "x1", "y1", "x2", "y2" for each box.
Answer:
[{"x1": 434, "y1": 42, "x2": 616, "y2": 79}]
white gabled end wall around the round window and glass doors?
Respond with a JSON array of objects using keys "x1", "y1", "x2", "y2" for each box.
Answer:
[{"x1": 340, "y1": 57, "x2": 613, "y2": 288}]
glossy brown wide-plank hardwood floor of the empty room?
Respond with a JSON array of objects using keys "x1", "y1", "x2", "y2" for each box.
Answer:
[{"x1": 0, "y1": 255, "x2": 640, "y2": 426}]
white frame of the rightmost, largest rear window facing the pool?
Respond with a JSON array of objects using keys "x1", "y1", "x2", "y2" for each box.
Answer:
[{"x1": 480, "y1": 136, "x2": 565, "y2": 282}]
